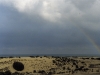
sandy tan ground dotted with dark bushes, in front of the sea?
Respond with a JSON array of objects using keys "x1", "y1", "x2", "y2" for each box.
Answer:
[{"x1": 0, "y1": 56, "x2": 100, "y2": 75}]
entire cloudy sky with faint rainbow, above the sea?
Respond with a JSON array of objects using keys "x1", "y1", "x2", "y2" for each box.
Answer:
[{"x1": 0, "y1": 0, "x2": 100, "y2": 54}]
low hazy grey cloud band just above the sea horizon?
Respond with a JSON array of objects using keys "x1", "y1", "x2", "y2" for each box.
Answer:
[{"x1": 0, "y1": 46, "x2": 99, "y2": 55}]
